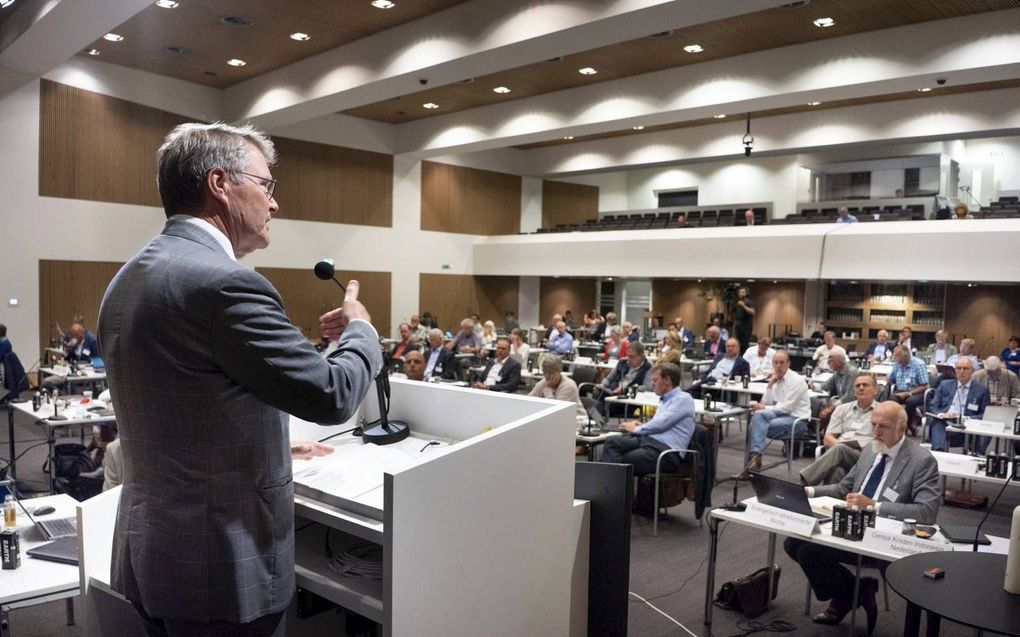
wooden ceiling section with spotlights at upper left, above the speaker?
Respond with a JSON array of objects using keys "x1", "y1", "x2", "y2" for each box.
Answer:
[{"x1": 80, "y1": 0, "x2": 465, "y2": 89}]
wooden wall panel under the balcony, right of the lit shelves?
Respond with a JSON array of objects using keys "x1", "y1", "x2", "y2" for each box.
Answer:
[{"x1": 946, "y1": 285, "x2": 1020, "y2": 358}]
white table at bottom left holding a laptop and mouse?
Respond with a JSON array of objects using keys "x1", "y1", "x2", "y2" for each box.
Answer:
[{"x1": 0, "y1": 493, "x2": 80, "y2": 636}]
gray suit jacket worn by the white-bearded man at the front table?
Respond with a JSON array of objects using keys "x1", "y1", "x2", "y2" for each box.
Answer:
[{"x1": 815, "y1": 438, "x2": 942, "y2": 524}]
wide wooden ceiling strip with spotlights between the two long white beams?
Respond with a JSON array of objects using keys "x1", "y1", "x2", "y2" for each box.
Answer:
[{"x1": 345, "y1": 0, "x2": 1020, "y2": 123}]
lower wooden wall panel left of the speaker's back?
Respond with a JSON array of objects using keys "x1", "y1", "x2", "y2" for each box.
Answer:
[{"x1": 37, "y1": 260, "x2": 123, "y2": 354}]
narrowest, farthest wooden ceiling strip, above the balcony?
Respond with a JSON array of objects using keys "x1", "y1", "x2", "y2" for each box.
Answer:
[{"x1": 514, "y1": 78, "x2": 1020, "y2": 149}]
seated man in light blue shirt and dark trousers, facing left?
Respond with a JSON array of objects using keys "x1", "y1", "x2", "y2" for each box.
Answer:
[{"x1": 602, "y1": 363, "x2": 695, "y2": 476}]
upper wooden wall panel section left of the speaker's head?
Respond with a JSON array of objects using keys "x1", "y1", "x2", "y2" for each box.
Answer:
[{"x1": 39, "y1": 79, "x2": 189, "y2": 206}]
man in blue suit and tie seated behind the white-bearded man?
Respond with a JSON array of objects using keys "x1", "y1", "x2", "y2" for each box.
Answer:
[{"x1": 928, "y1": 357, "x2": 990, "y2": 454}]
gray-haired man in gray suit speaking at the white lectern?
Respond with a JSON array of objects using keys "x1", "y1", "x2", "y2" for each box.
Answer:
[{"x1": 99, "y1": 124, "x2": 383, "y2": 636}]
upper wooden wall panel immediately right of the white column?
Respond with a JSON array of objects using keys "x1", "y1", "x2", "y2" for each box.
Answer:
[{"x1": 421, "y1": 161, "x2": 521, "y2": 234}]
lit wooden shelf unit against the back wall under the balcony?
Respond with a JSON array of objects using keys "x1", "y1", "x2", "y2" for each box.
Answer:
[{"x1": 825, "y1": 281, "x2": 946, "y2": 351}]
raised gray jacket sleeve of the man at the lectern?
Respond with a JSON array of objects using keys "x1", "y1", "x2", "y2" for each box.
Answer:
[{"x1": 210, "y1": 270, "x2": 383, "y2": 423}]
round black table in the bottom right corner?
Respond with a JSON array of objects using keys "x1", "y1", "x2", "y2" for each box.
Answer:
[{"x1": 885, "y1": 551, "x2": 1020, "y2": 637}]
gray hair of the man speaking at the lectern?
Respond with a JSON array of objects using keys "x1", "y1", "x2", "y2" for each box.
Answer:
[{"x1": 156, "y1": 122, "x2": 276, "y2": 217}]
